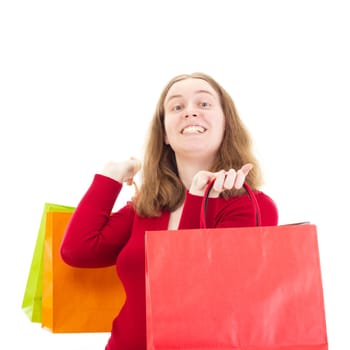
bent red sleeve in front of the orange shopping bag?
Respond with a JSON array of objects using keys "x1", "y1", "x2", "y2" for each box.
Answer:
[{"x1": 60, "y1": 175, "x2": 134, "y2": 267}]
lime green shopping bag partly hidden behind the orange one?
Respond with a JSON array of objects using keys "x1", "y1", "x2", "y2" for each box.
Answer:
[{"x1": 22, "y1": 203, "x2": 75, "y2": 323}]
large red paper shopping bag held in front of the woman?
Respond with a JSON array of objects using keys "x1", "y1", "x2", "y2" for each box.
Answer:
[{"x1": 146, "y1": 182, "x2": 328, "y2": 350}]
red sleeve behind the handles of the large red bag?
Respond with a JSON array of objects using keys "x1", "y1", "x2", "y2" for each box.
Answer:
[{"x1": 179, "y1": 191, "x2": 278, "y2": 229}]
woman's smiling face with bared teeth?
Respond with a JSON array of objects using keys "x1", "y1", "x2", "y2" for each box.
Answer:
[{"x1": 164, "y1": 78, "x2": 225, "y2": 159}]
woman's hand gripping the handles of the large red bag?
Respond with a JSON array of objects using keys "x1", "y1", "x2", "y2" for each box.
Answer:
[{"x1": 189, "y1": 163, "x2": 253, "y2": 198}]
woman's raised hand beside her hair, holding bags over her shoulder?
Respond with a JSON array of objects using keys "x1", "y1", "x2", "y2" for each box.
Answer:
[{"x1": 100, "y1": 158, "x2": 141, "y2": 185}]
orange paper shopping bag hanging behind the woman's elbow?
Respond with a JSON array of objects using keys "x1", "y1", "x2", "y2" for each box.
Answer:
[{"x1": 42, "y1": 212, "x2": 125, "y2": 333}]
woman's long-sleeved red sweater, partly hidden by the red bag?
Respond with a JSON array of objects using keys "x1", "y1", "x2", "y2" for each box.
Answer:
[{"x1": 61, "y1": 175, "x2": 278, "y2": 350}]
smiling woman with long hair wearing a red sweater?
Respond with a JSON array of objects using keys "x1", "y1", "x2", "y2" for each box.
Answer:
[{"x1": 61, "y1": 73, "x2": 278, "y2": 350}]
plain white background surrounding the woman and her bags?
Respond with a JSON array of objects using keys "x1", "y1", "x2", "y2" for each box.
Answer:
[{"x1": 0, "y1": 0, "x2": 350, "y2": 350}]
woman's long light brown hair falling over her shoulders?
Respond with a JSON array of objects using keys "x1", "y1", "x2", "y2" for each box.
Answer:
[{"x1": 134, "y1": 73, "x2": 261, "y2": 217}]
